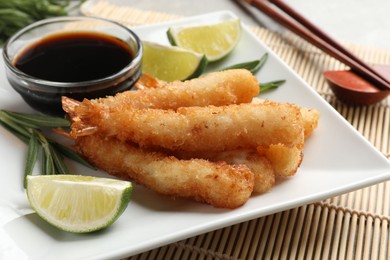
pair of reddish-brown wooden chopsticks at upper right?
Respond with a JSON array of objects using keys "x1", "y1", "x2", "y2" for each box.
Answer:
[{"x1": 246, "y1": 0, "x2": 390, "y2": 90}]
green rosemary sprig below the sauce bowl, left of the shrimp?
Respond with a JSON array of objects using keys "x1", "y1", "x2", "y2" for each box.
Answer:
[{"x1": 0, "y1": 110, "x2": 95, "y2": 186}]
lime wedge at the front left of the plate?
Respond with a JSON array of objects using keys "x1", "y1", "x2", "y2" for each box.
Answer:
[{"x1": 26, "y1": 175, "x2": 132, "y2": 233}]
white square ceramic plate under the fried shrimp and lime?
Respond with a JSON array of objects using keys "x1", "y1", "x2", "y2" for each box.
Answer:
[{"x1": 0, "y1": 12, "x2": 390, "y2": 260}]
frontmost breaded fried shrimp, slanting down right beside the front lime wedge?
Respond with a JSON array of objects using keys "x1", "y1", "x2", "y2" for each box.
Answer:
[{"x1": 76, "y1": 135, "x2": 254, "y2": 208}]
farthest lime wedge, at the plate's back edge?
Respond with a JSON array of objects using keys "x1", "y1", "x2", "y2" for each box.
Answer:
[{"x1": 167, "y1": 19, "x2": 241, "y2": 62}]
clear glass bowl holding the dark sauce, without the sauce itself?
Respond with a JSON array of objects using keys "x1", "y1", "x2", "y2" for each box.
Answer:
[{"x1": 3, "y1": 16, "x2": 143, "y2": 115}]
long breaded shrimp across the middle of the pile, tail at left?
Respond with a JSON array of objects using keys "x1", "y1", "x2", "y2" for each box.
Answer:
[{"x1": 66, "y1": 101, "x2": 304, "y2": 151}]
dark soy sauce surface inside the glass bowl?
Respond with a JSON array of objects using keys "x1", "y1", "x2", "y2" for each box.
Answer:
[{"x1": 13, "y1": 32, "x2": 133, "y2": 82}]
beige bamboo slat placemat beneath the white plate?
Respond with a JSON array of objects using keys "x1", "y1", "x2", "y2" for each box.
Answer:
[{"x1": 82, "y1": 1, "x2": 390, "y2": 259}]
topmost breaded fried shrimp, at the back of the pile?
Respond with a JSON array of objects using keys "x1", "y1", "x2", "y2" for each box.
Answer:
[{"x1": 63, "y1": 69, "x2": 259, "y2": 117}]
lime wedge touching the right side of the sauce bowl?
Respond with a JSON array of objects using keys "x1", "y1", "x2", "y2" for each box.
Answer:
[{"x1": 142, "y1": 41, "x2": 207, "y2": 82}]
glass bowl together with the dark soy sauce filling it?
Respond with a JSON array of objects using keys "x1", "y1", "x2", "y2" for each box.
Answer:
[{"x1": 3, "y1": 20, "x2": 143, "y2": 116}]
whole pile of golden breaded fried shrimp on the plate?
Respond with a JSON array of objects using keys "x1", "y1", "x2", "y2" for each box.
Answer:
[{"x1": 63, "y1": 70, "x2": 319, "y2": 208}]
